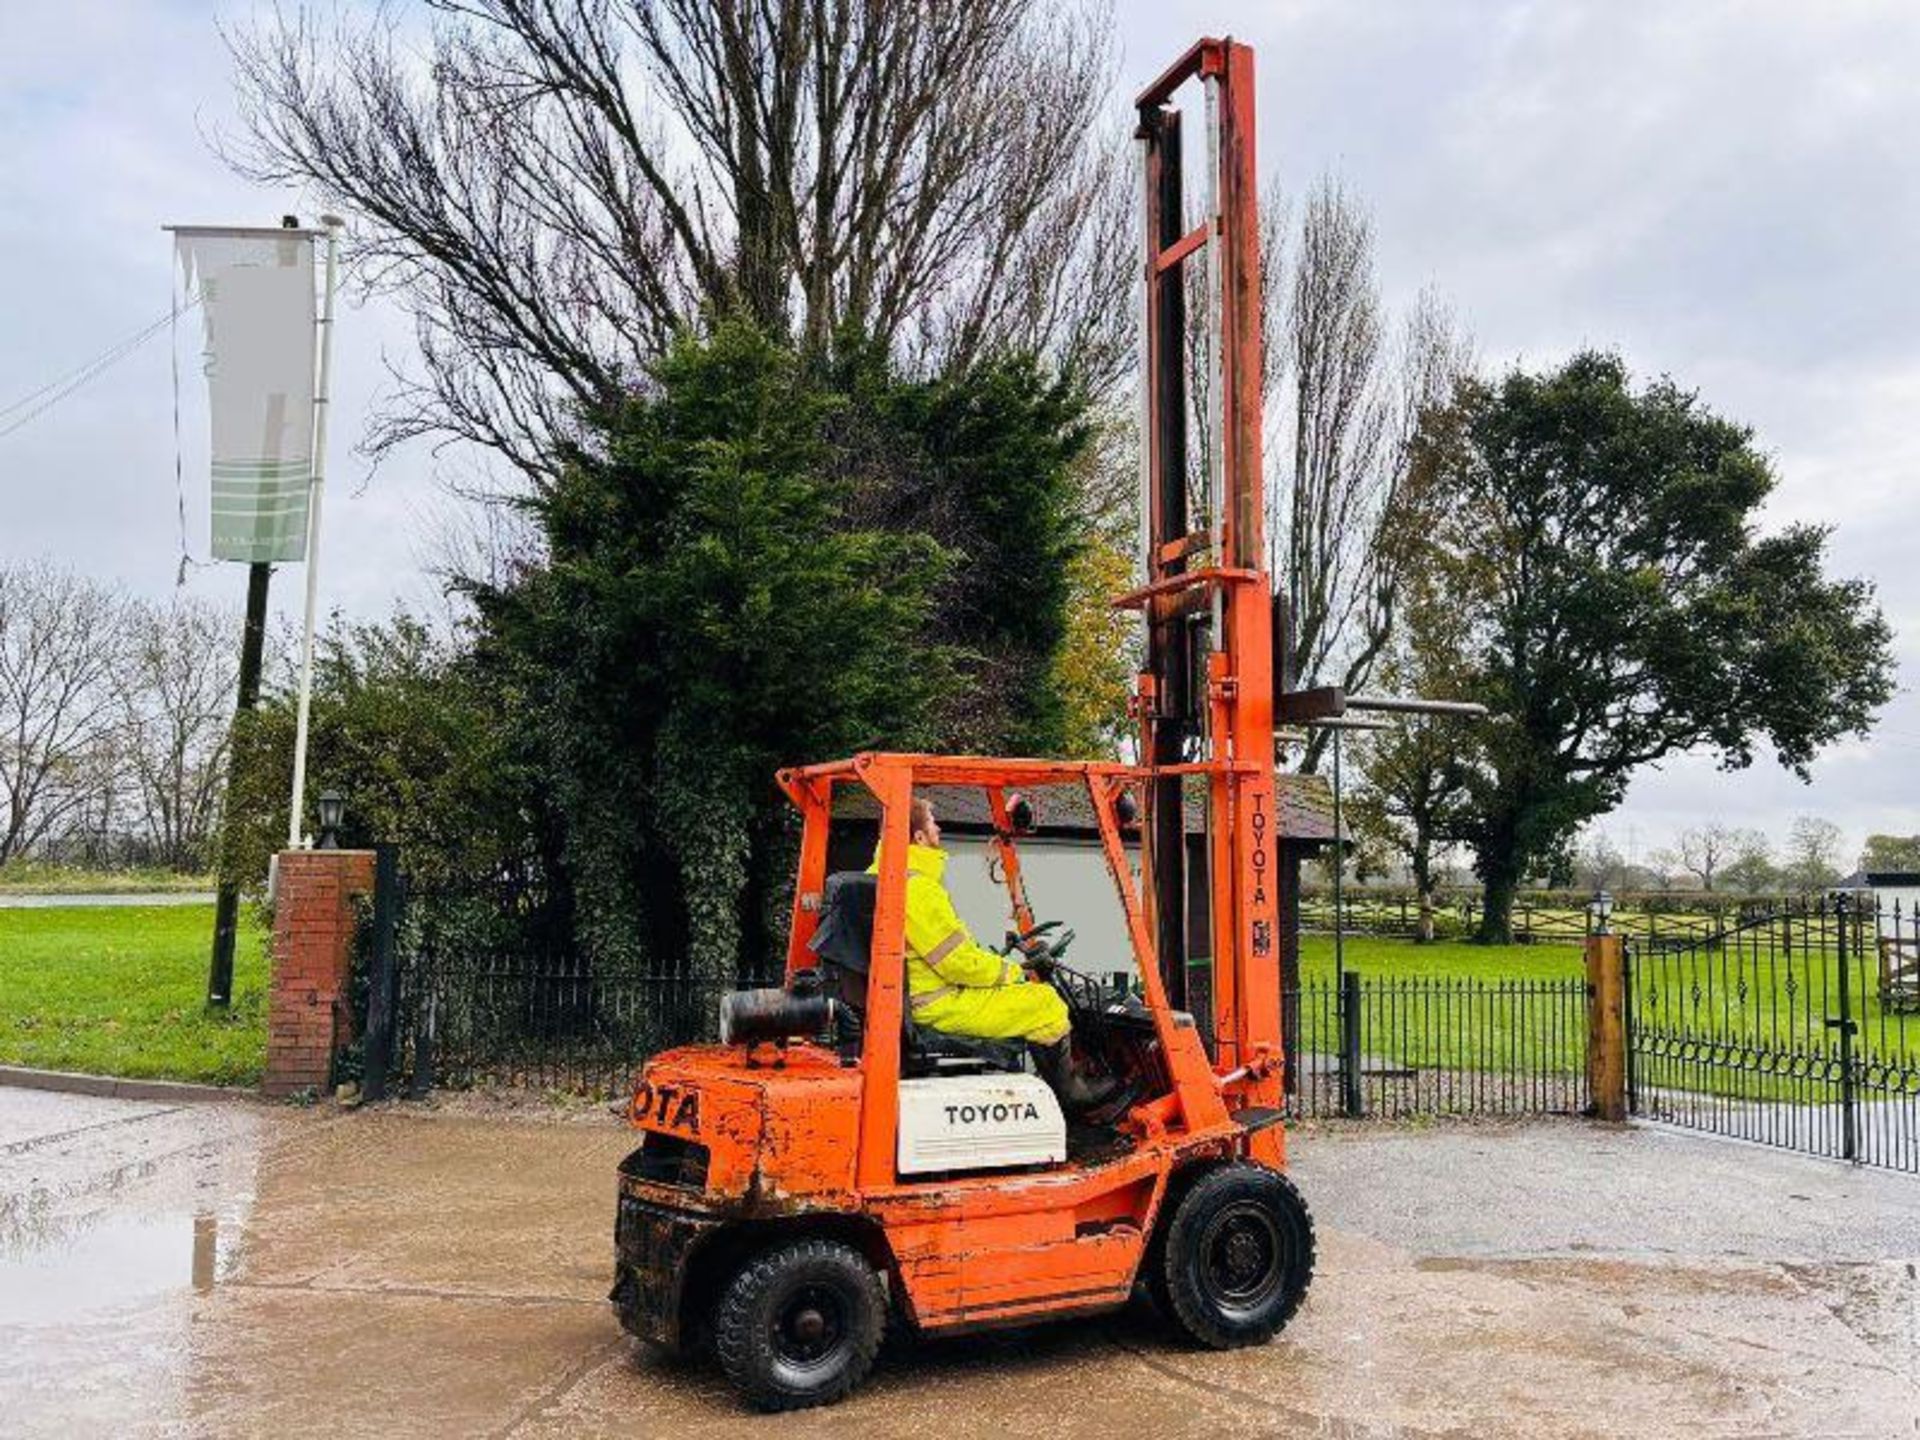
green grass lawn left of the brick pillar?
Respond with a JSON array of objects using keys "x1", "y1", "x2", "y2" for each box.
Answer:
[{"x1": 0, "y1": 904, "x2": 267, "y2": 1085}]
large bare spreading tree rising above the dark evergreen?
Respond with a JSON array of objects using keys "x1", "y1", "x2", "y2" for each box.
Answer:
[{"x1": 230, "y1": 0, "x2": 1133, "y2": 480}]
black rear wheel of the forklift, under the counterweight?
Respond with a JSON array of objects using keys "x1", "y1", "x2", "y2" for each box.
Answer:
[{"x1": 712, "y1": 1240, "x2": 887, "y2": 1409}]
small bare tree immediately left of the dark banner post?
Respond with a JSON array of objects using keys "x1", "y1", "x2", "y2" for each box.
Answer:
[{"x1": 117, "y1": 597, "x2": 238, "y2": 870}]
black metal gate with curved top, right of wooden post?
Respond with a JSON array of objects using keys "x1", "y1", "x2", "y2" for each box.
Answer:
[{"x1": 1626, "y1": 895, "x2": 1920, "y2": 1173}]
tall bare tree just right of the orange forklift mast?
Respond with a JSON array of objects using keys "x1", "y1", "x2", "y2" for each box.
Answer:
[{"x1": 1261, "y1": 179, "x2": 1471, "y2": 770}]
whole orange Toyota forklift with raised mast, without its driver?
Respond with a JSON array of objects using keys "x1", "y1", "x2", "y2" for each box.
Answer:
[{"x1": 612, "y1": 38, "x2": 1313, "y2": 1409}]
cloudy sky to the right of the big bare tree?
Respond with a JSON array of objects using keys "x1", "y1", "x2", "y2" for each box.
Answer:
[{"x1": 1119, "y1": 0, "x2": 1920, "y2": 845}]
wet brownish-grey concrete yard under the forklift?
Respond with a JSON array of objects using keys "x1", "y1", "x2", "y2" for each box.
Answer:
[{"x1": 0, "y1": 1089, "x2": 1920, "y2": 1438}]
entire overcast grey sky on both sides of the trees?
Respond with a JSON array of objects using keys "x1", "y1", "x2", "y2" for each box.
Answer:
[{"x1": 0, "y1": 0, "x2": 1920, "y2": 854}]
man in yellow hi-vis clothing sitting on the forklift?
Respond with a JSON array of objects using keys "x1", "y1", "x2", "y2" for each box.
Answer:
[{"x1": 868, "y1": 799, "x2": 1116, "y2": 1110}]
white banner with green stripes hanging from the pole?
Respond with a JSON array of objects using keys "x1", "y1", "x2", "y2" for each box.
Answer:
[{"x1": 175, "y1": 230, "x2": 315, "y2": 561}]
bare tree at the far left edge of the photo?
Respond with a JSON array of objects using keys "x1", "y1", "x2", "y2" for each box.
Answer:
[{"x1": 0, "y1": 563, "x2": 125, "y2": 864}]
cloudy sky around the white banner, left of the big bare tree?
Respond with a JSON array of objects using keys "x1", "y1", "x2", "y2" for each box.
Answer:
[{"x1": 0, "y1": 0, "x2": 434, "y2": 616}]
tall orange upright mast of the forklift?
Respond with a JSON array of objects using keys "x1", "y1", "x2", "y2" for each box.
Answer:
[{"x1": 1116, "y1": 38, "x2": 1281, "y2": 1089}]
